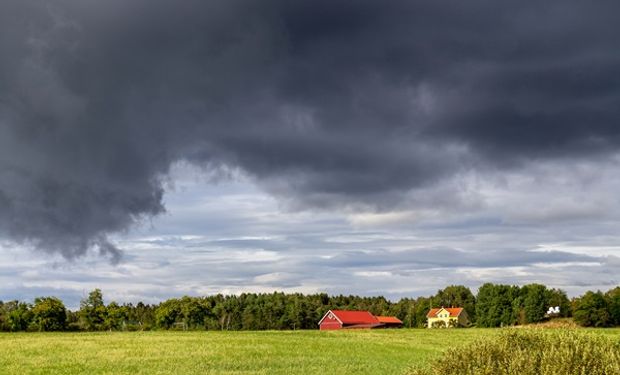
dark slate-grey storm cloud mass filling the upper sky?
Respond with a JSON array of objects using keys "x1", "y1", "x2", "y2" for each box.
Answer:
[{"x1": 0, "y1": 0, "x2": 620, "y2": 259}]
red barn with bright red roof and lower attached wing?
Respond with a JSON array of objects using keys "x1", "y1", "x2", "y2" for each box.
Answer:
[{"x1": 319, "y1": 310, "x2": 403, "y2": 330}]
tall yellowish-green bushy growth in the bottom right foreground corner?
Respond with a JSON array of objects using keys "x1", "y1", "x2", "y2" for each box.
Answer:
[{"x1": 410, "y1": 330, "x2": 620, "y2": 375}]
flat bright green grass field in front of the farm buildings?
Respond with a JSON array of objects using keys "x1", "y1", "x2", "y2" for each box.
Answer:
[{"x1": 0, "y1": 329, "x2": 620, "y2": 375}]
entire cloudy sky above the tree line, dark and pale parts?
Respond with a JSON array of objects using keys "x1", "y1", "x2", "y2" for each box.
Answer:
[{"x1": 0, "y1": 0, "x2": 620, "y2": 308}]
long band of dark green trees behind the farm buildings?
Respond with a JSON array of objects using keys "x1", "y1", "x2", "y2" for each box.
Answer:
[{"x1": 0, "y1": 283, "x2": 620, "y2": 331}]
